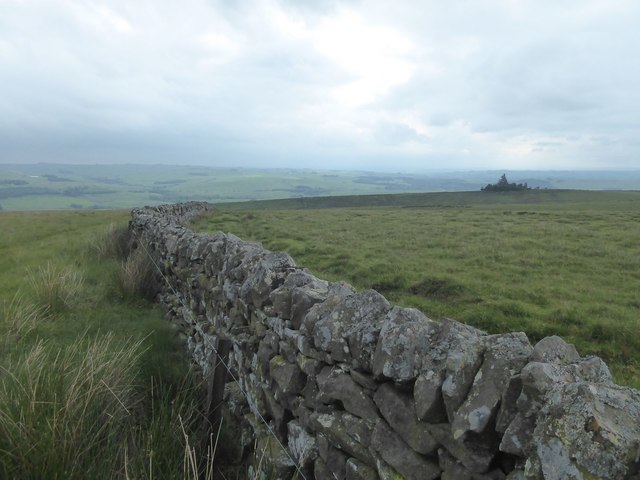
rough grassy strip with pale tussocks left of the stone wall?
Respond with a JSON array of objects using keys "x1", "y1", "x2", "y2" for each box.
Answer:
[{"x1": 0, "y1": 211, "x2": 215, "y2": 479}]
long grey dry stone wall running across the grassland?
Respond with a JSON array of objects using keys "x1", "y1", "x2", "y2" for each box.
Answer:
[{"x1": 130, "y1": 203, "x2": 640, "y2": 480}]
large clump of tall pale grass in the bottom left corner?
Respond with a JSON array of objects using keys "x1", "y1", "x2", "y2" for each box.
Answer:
[{"x1": 0, "y1": 334, "x2": 142, "y2": 479}]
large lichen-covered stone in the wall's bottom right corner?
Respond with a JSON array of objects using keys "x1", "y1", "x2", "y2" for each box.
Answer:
[{"x1": 525, "y1": 382, "x2": 640, "y2": 480}]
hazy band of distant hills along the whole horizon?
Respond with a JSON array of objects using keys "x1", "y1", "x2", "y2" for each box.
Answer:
[{"x1": 0, "y1": 163, "x2": 640, "y2": 210}]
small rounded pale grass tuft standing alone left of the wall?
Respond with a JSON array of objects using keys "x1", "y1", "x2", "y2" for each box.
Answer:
[{"x1": 28, "y1": 262, "x2": 84, "y2": 314}]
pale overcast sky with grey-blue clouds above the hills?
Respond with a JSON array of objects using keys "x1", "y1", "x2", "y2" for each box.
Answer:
[{"x1": 0, "y1": 0, "x2": 640, "y2": 171}]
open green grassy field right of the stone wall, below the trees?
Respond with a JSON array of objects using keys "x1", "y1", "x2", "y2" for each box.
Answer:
[{"x1": 194, "y1": 191, "x2": 640, "y2": 388}]
